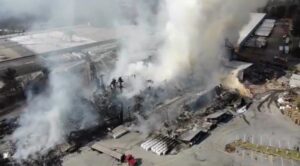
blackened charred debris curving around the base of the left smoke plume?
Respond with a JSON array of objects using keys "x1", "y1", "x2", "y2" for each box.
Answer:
[{"x1": 0, "y1": 87, "x2": 123, "y2": 166}]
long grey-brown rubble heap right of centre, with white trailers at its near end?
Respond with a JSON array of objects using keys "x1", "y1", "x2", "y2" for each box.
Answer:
[{"x1": 133, "y1": 86, "x2": 252, "y2": 155}]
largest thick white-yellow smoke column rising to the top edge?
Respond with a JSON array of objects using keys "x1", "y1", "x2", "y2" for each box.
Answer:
[{"x1": 113, "y1": 0, "x2": 266, "y2": 97}]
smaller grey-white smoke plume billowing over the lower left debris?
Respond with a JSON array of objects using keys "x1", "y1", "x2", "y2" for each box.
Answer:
[{"x1": 12, "y1": 65, "x2": 99, "y2": 159}]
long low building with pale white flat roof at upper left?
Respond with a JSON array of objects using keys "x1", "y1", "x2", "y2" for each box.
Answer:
[{"x1": 0, "y1": 25, "x2": 121, "y2": 75}]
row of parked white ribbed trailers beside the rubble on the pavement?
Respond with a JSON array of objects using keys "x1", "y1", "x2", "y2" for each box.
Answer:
[{"x1": 141, "y1": 136, "x2": 177, "y2": 156}]
